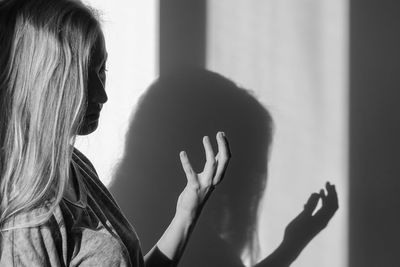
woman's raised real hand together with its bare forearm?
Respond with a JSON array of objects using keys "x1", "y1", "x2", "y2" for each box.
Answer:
[{"x1": 150, "y1": 132, "x2": 231, "y2": 266}]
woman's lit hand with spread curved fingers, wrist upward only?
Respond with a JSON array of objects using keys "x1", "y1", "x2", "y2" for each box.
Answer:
[{"x1": 177, "y1": 132, "x2": 231, "y2": 219}]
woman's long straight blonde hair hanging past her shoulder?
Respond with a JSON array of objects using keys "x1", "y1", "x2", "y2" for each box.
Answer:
[{"x1": 0, "y1": 0, "x2": 100, "y2": 231}]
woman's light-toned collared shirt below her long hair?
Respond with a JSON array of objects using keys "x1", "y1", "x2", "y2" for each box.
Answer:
[{"x1": 0, "y1": 148, "x2": 144, "y2": 267}]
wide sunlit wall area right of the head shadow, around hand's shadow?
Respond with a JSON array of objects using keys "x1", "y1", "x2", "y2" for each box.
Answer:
[{"x1": 207, "y1": 0, "x2": 348, "y2": 267}]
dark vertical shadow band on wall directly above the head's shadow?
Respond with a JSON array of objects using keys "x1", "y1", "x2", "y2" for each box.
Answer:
[{"x1": 159, "y1": 0, "x2": 207, "y2": 75}]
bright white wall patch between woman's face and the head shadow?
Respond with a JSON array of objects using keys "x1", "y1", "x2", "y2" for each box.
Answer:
[{"x1": 76, "y1": 0, "x2": 158, "y2": 188}]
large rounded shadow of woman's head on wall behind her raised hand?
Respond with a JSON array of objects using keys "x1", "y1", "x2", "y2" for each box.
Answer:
[{"x1": 111, "y1": 69, "x2": 272, "y2": 267}]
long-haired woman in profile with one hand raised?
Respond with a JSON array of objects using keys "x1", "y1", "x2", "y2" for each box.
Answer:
[{"x1": 0, "y1": 0, "x2": 230, "y2": 266}]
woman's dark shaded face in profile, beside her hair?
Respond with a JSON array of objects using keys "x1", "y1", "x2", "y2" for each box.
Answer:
[{"x1": 78, "y1": 31, "x2": 107, "y2": 135}]
